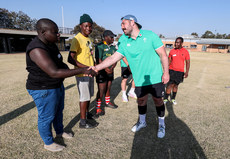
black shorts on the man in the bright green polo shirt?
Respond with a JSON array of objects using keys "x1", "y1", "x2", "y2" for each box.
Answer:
[{"x1": 135, "y1": 83, "x2": 165, "y2": 98}]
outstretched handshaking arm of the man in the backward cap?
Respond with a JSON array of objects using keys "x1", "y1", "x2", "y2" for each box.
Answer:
[{"x1": 95, "y1": 52, "x2": 123, "y2": 71}]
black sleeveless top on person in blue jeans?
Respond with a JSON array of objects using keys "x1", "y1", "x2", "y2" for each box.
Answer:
[{"x1": 26, "y1": 37, "x2": 68, "y2": 90}]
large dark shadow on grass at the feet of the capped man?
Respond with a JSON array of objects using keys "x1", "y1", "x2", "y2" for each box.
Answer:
[{"x1": 131, "y1": 96, "x2": 207, "y2": 159}]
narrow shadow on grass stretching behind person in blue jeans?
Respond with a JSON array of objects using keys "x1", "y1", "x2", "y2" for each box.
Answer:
[{"x1": 0, "y1": 84, "x2": 76, "y2": 126}]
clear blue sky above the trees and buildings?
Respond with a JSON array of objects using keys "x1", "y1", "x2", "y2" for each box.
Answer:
[{"x1": 0, "y1": 0, "x2": 230, "y2": 37}]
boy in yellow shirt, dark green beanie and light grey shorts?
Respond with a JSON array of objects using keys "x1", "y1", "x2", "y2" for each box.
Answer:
[{"x1": 68, "y1": 14, "x2": 97, "y2": 129}]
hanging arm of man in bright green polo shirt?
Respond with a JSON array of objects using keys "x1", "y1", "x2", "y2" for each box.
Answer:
[{"x1": 156, "y1": 46, "x2": 169, "y2": 84}]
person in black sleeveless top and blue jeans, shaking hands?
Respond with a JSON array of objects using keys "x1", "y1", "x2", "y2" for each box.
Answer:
[{"x1": 26, "y1": 18, "x2": 96, "y2": 151}]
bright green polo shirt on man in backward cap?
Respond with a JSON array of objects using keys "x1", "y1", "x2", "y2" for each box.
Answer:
[{"x1": 117, "y1": 30, "x2": 163, "y2": 87}]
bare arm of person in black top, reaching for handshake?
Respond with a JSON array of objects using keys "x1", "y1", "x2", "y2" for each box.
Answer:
[{"x1": 29, "y1": 48, "x2": 94, "y2": 78}]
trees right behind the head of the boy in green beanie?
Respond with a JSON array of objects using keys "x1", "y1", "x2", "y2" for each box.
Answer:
[{"x1": 73, "y1": 22, "x2": 105, "y2": 43}]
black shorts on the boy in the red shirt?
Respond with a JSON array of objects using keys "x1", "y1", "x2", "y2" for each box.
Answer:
[{"x1": 168, "y1": 70, "x2": 184, "y2": 85}]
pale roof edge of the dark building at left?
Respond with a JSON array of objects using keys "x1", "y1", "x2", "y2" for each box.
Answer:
[{"x1": 0, "y1": 28, "x2": 73, "y2": 38}]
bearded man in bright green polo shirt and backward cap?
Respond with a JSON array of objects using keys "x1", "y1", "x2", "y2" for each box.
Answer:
[{"x1": 91, "y1": 15, "x2": 169, "y2": 138}]
